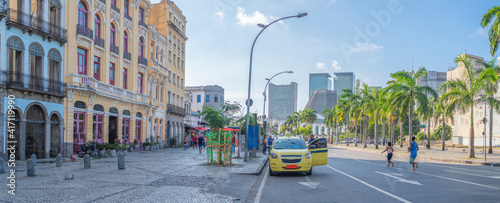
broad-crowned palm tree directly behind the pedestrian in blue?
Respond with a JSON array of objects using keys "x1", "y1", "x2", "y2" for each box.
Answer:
[{"x1": 384, "y1": 67, "x2": 437, "y2": 142}]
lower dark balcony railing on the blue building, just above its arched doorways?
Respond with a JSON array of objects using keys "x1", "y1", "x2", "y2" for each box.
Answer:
[{"x1": 1, "y1": 71, "x2": 66, "y2": 97}]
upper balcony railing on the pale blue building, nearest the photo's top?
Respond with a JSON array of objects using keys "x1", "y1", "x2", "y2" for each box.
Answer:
[{"x1": 6, "y1": 9, "x2": 67, "y2": 43}]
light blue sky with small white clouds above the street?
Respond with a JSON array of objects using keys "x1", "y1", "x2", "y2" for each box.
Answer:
[{"x1": 152, "y1": 0, "x2": 498, "y2": 114}]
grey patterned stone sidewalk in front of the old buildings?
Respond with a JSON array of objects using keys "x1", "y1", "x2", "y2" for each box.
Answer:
[{"x1": 0, "y1": 148, "x2": 267, "y2": 203}]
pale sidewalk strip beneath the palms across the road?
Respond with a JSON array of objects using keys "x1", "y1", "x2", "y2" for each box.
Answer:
[{"x1": 328, "y1": 143, "x2": 500, "y2": 166}]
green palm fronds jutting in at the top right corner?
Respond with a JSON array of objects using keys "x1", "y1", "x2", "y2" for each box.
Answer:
[{"x1": 481, "y1": 6, "x2": 500, "y2": 56}]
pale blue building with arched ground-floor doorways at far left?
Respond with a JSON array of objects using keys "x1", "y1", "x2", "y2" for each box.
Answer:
[{"x1": 0, "y1": 0, "x2": 67, "y2": 160}]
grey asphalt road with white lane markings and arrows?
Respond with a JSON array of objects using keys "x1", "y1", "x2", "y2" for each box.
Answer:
[{"x1": 244, "y1": 148, "x2": 500, "y2": 203}]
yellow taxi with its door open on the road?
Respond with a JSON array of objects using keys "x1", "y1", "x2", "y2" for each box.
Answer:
[{"x1": 269, "y1": 137, "x2": 328, "y2": 176}]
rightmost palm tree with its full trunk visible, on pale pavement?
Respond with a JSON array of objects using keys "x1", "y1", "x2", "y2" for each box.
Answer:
[{"x1": 441, "y1": 54, "x2": 499, "y2": 158}]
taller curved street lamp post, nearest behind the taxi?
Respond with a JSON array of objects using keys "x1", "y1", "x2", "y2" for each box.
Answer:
[{"x1": 244, "y1": 13, "x2": 307, "y2": 162}]
